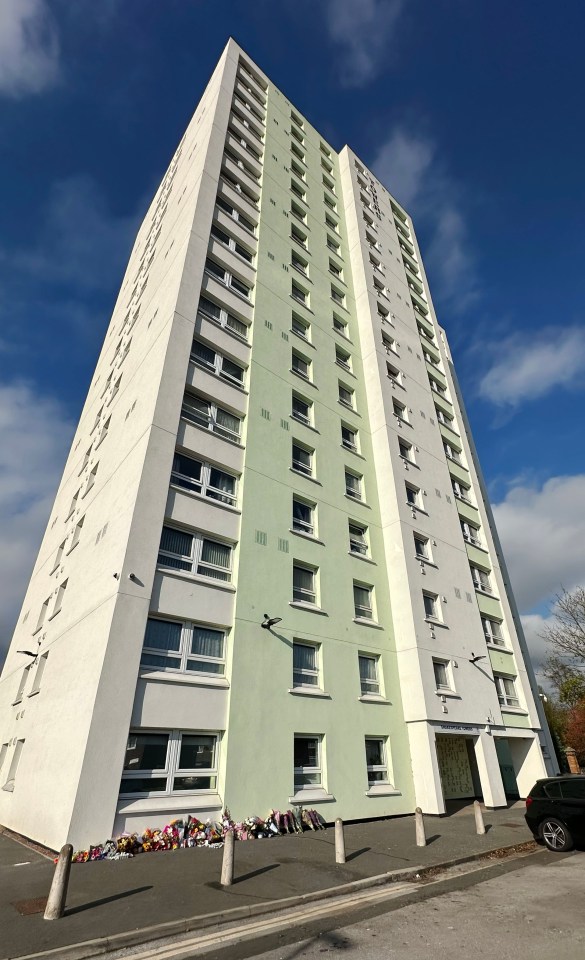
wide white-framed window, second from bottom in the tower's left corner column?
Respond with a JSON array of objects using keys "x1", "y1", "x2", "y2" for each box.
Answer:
[{"x1": 140, "y1": 617, "x2": 225, "y2": 676}]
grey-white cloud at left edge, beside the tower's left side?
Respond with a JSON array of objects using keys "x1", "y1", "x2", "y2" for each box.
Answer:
[{"x1": 0, "y1": 383, "x2": 74, "y2": 662}]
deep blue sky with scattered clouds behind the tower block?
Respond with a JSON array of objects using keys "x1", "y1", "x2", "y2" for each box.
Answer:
[{"x1": 0, "y1": 0, "x2": 585, "y2": 676}]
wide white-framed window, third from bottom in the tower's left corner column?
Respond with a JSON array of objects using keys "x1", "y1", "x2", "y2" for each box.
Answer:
[{"x1": 158, "y1": 527, "x2": 232, "y2": 581}]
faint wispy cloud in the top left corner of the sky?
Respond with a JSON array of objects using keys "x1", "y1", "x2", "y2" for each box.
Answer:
[{"x1": 0, "y1": 0, "x2": 59, "y2": 97}]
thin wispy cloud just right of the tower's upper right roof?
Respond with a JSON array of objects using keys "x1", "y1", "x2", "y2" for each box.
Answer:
[{"x1": 371, "y1": 127, "x2": 478, "y2": 312}]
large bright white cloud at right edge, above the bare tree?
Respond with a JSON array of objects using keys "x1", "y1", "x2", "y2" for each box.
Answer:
[{"x1": 493, "y1": 474, "x2": 585, "y2": 614}]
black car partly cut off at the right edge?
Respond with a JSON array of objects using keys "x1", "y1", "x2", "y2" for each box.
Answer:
[{"x1": 524, "y1": 774, "x2": 585, "y2": 851}]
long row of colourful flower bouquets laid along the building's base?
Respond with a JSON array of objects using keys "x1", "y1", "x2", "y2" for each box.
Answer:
[{"x1": 73, "y1": 807, "x2": 325, "y2": 863}]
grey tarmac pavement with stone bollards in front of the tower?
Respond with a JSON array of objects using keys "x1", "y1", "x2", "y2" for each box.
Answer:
[{"x1": 0, "y1": 803, "x2": 532, "y2": 960}]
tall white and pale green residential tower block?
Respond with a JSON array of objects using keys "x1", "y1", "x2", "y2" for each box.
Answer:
[{"x1": 0, "y1": 41, "x2": 554, "y2": 847}]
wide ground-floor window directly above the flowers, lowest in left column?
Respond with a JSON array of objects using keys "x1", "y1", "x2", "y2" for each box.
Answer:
[{"x1": 120, "y1": 730, "x2": 218, "y2": 797}]
